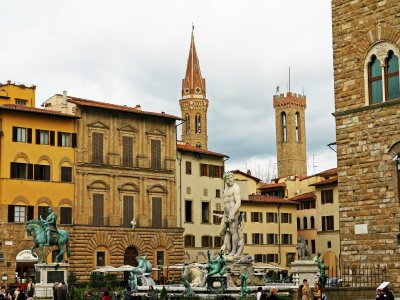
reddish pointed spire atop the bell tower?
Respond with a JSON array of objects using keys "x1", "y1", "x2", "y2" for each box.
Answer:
[{"x1": 182, "y1": 27, "x2": 206, "y2": 98}]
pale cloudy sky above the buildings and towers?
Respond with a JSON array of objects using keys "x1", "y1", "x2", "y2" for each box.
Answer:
[{"x1": 0, "y1": 0, "x2": 336, "y2": 180}]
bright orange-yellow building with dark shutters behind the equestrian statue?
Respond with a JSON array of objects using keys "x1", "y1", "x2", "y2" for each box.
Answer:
[{"x1": 0, "y1": 95, "x2": 76, "y2": 282}]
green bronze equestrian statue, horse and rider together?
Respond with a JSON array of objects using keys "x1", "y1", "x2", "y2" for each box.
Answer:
[{"x1": 25, "y1": 207, "x2": 71, "y2": 263}]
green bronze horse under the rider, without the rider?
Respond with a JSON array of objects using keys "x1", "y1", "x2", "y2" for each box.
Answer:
[{"x1": 25, "y1": 220, "x2": 71, "y2": 263}]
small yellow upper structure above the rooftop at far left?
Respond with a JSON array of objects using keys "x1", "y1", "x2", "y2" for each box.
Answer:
[{"x1": 0, "y1": 80, "x2": 36, "y2": 107}]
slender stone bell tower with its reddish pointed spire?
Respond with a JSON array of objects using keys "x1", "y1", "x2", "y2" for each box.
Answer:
[{"x1": 179, "y1": 32, "x2": 208, "y2": 149}]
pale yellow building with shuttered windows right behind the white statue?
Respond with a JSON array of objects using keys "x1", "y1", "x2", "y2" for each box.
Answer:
[{"x1": 232, "y1": 170, "x2": 297, "y2": 268}]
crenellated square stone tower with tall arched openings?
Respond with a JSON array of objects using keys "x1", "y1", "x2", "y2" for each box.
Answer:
[{"x1": 274, "y1": 92, "x2": 307, "y2": 177}]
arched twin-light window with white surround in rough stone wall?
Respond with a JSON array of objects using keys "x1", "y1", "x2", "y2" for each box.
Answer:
[{"x1": 365, "y1": 42, "x2": 400, "y2": 104}]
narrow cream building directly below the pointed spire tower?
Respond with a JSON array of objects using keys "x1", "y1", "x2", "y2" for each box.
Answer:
[{"x1": 176, "y1": 144, "x2": 227, "y2": 262}]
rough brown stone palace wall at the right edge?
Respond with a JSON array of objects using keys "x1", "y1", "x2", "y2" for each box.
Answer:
[{"x1": 332, "y1": 0, "x2": 400, "y2": 290}]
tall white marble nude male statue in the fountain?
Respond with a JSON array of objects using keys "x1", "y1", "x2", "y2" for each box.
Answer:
[{"x1": 220, "y1": 172, "x2": 241, "y2": 256}]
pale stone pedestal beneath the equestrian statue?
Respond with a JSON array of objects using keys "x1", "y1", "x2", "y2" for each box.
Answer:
[{"x1": 35, "y1": 263, "x2": 69, "y2": 299}]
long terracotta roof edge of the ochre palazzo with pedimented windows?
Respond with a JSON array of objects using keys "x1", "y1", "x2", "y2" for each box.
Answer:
[{"x1": 67, "y1": 97, "x2": 182, "y2": 120}]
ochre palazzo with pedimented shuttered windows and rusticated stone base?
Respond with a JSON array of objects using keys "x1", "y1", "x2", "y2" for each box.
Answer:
[{"x1": 44, "y1": 95, "x2": 183, "y2": 280}]
